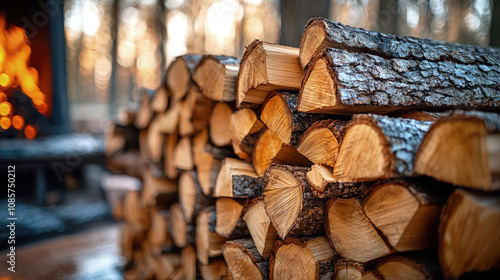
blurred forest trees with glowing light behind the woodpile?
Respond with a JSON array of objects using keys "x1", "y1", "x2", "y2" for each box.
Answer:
[{"x1": 65, "y1": 0, "x2": 500, "y2": 130}]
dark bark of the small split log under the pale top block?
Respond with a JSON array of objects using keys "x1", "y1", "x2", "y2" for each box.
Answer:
[{"x1": 261, "y1": 91, "x2": 330, "y2": 145}]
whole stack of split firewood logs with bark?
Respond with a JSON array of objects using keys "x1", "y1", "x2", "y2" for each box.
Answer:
[{"x1": 109, "y1": 19, "x2": 500, "y2": 279}]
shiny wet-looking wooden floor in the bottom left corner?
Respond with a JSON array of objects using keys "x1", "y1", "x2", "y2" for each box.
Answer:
[{"x1": 0, "y1": 223, "x2": 123, "y2": 280}]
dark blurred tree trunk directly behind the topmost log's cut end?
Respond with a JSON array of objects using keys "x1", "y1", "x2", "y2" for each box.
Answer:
[{"x1": 280, "y1": 0, "x2": 330, "y2": 48}]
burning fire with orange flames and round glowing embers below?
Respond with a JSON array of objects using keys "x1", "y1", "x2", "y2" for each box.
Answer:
[{"x1": 0, "y1": 14, "x2": 49, "y2": 139}]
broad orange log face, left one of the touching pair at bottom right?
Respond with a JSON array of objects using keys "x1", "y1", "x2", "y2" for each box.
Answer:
[{"x1": 325, "y1": 198, "x2": 392, "y2": 263}]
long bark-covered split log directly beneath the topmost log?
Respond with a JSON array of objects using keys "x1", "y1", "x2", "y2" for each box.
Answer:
[{"x1": 297, "y1": 49, "x2": 500, "y2": 115}]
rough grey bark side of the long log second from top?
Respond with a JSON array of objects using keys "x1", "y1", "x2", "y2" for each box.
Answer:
[{"x1": 304, "y1": 47, "x2": 500, "y2": 108}]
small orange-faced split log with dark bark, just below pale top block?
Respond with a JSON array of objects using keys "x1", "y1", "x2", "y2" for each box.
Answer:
[{"x1": 260, "y1": 91, "x2": 327, "y2": 145}]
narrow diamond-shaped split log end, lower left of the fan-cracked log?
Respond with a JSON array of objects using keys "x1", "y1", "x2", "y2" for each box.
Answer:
[{"x1": 243, "y1": 198, "x2": 278, "y2": 258}]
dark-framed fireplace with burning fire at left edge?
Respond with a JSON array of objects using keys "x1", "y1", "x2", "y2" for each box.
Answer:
[{"x1": 0, "y1": 0, "x2": 70, "y2": 139}]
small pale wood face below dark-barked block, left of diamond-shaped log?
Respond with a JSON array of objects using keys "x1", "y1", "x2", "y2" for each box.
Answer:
[{"x1": 215, "y1": 197, "x2": 248, "y2": 237}]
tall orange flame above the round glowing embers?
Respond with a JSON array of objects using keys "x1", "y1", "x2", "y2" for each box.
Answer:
[{"x1": 0, "y1": 14, "x2": 49, "y2": 116}]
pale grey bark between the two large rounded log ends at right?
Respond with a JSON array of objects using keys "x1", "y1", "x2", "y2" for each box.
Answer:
[{"x1": 348, "y1": 114, "x2": 432, "y2": 176}]
